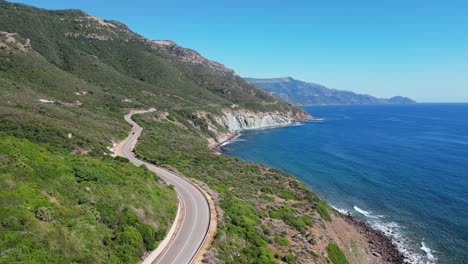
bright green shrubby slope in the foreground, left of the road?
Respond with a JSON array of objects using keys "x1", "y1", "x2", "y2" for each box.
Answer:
[{"x1": 0, "y1": 134, "x2": 177, "y2": 263}]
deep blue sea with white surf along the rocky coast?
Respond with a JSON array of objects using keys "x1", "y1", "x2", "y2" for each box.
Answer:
[{"x1": 226, "y1": 104, "x2": 468, "y2": 264}]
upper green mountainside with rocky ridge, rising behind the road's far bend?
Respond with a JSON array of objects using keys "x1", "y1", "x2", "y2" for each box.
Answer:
[{"x1": 0, "y1": 1, "x2": 301, "y2": 151}]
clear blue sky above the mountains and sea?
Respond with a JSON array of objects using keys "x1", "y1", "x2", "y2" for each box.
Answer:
[{"x1": 7, "y1": 0, "x2": 468, "y2": 102}]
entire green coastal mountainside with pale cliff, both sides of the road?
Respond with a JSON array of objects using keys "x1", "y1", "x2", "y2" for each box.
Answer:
[{"x1": 0, "y1": 1, "x2": 390, "y2": 263}]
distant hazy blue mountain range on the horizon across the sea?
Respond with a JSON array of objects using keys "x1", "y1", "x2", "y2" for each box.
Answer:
[{"x1": 244, "y1": 77, "x2": 416, "y2": 105}]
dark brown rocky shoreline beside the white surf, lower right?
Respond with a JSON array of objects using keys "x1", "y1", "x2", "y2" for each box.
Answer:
[{"x1": 338, "y1": 212, "x2": 406, "y2": 264}]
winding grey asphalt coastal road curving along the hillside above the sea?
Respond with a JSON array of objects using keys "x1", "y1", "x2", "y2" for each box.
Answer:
[{"x1": 116, "y1": 110, "x2": 211, "y2": 264}]
